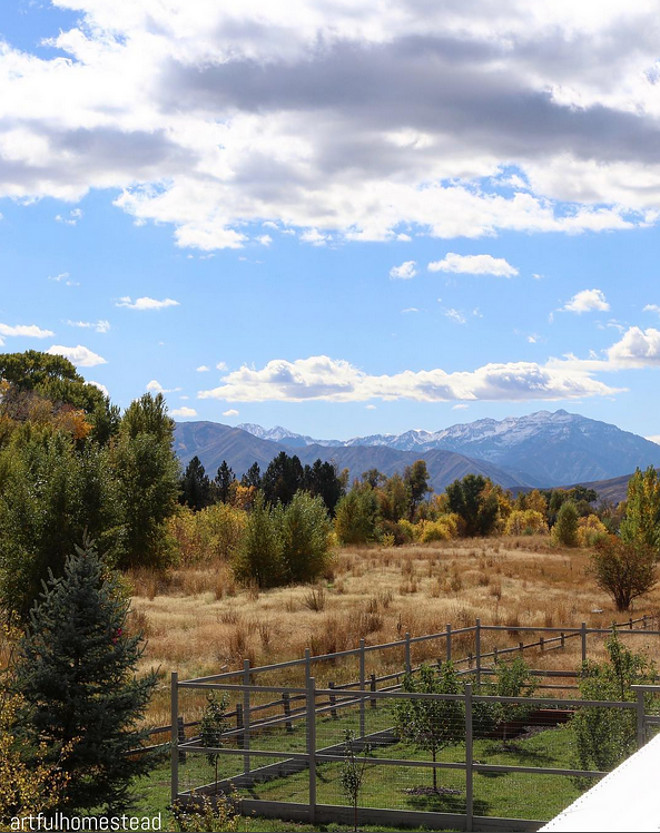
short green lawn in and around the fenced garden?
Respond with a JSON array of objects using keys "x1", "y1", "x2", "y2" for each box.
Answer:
[{"x1": 130, "y1": 708, "x2": 592, "y2": 833}]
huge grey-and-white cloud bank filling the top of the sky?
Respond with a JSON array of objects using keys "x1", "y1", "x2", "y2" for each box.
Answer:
[{"x1": 0, "y1": 0, "x2": 660, "y2": 251}]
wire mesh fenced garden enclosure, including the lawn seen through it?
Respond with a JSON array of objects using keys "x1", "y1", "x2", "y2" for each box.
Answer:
[{"x1": 171, "y1": 620, "x2": 660, "y2": 830}]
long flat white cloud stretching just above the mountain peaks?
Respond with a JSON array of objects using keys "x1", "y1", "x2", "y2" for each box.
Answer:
[{"x1": 198, "y1": 356, "x2": 616, "y2": 402}]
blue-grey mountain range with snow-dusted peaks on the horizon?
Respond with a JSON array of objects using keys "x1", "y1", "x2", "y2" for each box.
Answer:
[{"x1": 175, "y1": 410, "x2": 660, "y2": 492}]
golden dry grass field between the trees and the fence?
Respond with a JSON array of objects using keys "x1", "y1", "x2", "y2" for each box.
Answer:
[{"x1": 130, "y1": 536, "x2": 660, "y2": 723}]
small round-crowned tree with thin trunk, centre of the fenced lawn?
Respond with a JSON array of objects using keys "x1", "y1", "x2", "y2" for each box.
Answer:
[{"x1": 394, "y1": 662, "x2": 465, "y2": 791}]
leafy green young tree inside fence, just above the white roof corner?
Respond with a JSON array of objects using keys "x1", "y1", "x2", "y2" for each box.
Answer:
[{"x1": 571, "y1": 632, "x2": 655, "y2": 786}]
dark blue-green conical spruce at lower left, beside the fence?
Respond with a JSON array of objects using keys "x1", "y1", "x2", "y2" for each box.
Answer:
[{"x1": 15, "y1": 542, "x2": 156, "y2": 813}]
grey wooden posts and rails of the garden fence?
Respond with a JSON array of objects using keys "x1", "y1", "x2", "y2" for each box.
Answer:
[{"x1": 169, "y1": 616, "x2": 660, "y2": 830}]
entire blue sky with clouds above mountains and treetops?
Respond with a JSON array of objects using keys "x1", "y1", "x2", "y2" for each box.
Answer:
[{"x1": 0, "y1": 0, "x2": 660, "y2": 439}]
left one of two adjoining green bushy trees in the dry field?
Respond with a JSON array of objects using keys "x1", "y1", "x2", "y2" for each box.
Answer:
[{"x1": 233, "y1": 493, "x2": 286, "y2": 587}]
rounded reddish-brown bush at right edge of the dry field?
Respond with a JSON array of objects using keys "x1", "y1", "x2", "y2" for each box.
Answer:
[{"x1": 591, "y1": 535, "x2": 657, "y2": 611}]
